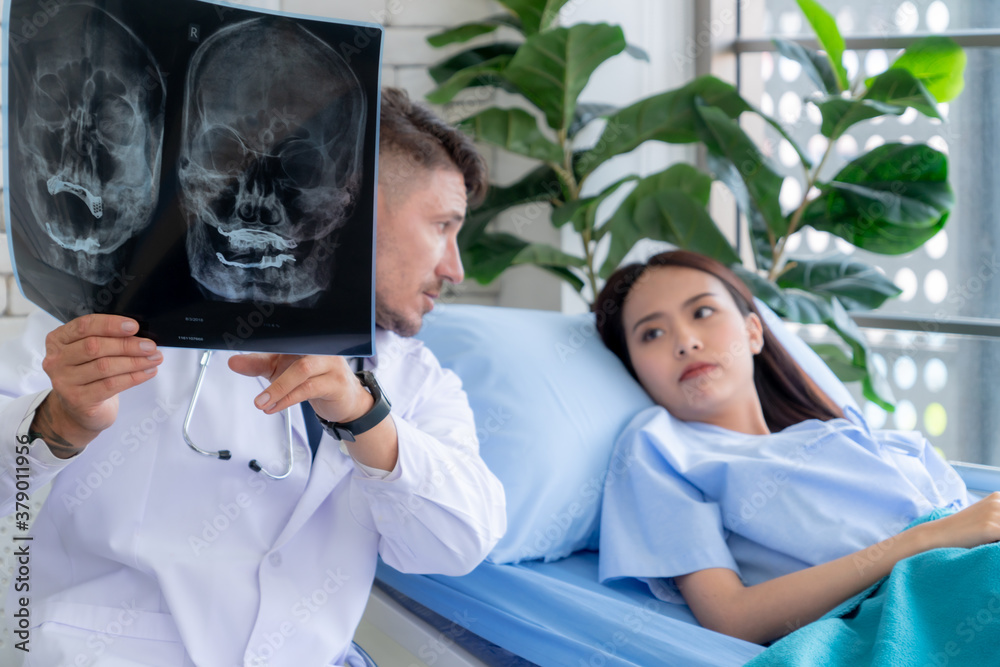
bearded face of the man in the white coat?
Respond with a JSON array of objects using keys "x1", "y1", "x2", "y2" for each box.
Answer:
[{"x1": 375, "y1": 169, "x2": 466, "y2": 336}]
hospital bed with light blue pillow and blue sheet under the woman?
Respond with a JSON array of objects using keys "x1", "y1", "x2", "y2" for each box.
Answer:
[{"x1": 361, "y1": 304, "x2": 1000, "y2": 667}]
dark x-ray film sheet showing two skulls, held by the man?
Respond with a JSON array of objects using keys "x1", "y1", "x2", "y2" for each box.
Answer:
[{"x1": 3, "y1": 0, "x2": 383, "y2": 355}]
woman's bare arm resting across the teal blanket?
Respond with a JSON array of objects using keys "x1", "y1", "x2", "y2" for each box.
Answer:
[{"x1": 675, "y1": 493, "x2": 1000, "y2": 644}]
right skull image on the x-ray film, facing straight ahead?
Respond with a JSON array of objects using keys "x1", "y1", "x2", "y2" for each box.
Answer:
[{"x1": 179, "y1": 17, "x2": 367, "y2": 306}]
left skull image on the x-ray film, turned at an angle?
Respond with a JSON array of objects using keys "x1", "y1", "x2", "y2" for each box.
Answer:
[{"x1": 14, "y1": 3, "x2": 165, "y2": 285}]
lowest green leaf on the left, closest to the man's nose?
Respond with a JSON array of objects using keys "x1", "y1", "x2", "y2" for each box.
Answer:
[{"x1": 462, "y1": 233, "x2": 586, "y2": 285}]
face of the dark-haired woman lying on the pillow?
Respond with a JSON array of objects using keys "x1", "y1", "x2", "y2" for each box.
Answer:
[{"x1": 622, "y1": 267, "x2": 763, "y2": 425}]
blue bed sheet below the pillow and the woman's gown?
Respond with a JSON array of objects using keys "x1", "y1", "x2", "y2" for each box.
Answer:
[{"x1": 376, "y1": 551, "x2": 764, "y2": 667}]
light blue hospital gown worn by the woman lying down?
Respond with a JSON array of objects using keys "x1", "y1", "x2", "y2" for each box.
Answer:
[{"x1": 600, "y1": 407, "x2": 970, "y2": 603}]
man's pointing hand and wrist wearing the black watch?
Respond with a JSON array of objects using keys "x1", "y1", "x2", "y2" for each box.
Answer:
[{"x1": 229, "y1": 354, "x2": 398, "y2": 470}]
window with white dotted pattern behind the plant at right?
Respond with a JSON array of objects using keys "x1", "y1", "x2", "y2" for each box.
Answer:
[{"x1": 716, "y1": 0, "x2": 1000, "y2": 465}]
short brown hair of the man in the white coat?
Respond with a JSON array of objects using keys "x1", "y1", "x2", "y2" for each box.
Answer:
[{"x1": 379, "y1": 88, "x2": 489, "y2": 208}]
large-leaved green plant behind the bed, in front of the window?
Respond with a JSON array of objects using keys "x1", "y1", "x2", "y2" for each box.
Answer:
[{"x1": 428, "y1": 0, "x2": 965, "y2": 410}]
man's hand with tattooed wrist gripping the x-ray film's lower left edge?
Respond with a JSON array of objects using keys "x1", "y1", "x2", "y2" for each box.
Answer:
[{"x1": 36, "y1": 314, "x2": 163, "y2": 459}]
